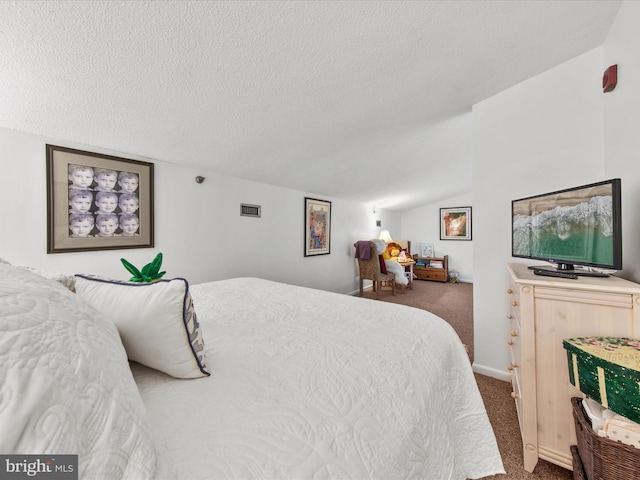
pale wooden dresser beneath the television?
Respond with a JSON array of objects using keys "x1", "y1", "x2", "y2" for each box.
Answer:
[{"x1": 507, "y1": 263, "x2": 640, "y2": 472}]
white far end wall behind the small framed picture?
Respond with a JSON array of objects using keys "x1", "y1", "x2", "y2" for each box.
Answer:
[{"x1": 401, "y1": 193, "x2": 474, "y2": 282}]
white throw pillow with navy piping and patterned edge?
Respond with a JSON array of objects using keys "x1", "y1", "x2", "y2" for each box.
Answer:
[{"x1": 76, "y1": 275, "x2": 209, "y2": 378}]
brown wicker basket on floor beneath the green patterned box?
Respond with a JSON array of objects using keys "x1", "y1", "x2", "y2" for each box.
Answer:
[{"x1": 571, "y1": 397, "x2": 640, "y2": 480}]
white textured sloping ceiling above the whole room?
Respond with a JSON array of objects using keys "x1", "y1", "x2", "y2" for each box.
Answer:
[{"x1": 0, "y1": 0, "x2": 620, "y2": 210}]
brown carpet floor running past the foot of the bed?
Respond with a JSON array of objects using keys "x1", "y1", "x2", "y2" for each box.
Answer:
[{"x1": 364, "y1": 280, "x2": 573, "y2": 480}]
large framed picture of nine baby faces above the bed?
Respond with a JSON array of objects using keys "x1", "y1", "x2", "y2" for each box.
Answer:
[{"x1": 46, "y1": 145, "x2": 153, "y2": 253}]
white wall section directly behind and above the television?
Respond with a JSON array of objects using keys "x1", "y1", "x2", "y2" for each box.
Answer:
[{"x1": 473, "y1": 48, "x2": 608, "y2": 379}]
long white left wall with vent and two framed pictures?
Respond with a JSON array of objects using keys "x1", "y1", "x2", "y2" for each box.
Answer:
[{"x1": 0, "y1": 128, "x2": 400, "y2": 293}]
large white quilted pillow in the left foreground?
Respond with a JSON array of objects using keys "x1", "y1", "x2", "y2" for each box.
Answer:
[{"x1": 0, "y1": 263, "x2": 173, "y2": 479}]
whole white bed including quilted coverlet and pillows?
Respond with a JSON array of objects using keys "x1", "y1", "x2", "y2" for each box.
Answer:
[{"x1": 0, "y1": 262, "x2": 504, "y2": 480}]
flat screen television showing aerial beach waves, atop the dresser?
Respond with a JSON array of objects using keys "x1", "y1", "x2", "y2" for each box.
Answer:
[{"x1": 511, "y1": 178, "x2": 622, "y2": 275}]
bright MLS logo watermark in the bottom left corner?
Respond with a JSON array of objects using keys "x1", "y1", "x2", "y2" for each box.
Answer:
[{"x1": 0, "y1": 454, "x2": 78, "y2": 480}]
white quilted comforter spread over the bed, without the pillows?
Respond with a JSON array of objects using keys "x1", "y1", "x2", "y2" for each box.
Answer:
[{"x1": 132, "y1": 278, "x2": 504, "y2": 480}]
